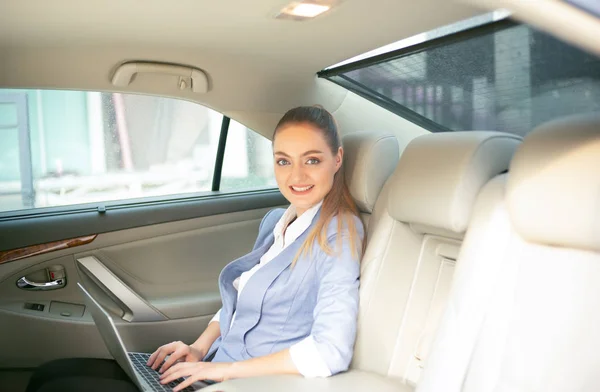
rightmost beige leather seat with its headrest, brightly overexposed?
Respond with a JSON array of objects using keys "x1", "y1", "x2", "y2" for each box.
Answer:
[{"x1": 417, "y1": 114, "x2": 600, "y2": 392}]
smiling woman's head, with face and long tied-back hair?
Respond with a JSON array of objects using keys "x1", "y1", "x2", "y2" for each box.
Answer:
[{"x1": 273, "y1": 106, "x2": 366, "y2": 264}]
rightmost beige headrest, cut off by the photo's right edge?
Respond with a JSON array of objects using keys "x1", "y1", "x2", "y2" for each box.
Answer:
[{"x1": 506, "y1": 113, "x2": 600, "y2": 251}]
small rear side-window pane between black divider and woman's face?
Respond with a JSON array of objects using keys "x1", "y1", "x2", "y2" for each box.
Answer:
[{"x1": 220, "y1": 120, "x2": 277, "y2": 191}]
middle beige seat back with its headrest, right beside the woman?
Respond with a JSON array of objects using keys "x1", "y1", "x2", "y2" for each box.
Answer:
[{"x1": 352, "y1": 131, "x2": 521, "y2": 384}]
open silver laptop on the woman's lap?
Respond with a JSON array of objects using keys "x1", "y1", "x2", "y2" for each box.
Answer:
[{"x1": 77, "y1": 283, "x2": 214, "y2": 392}]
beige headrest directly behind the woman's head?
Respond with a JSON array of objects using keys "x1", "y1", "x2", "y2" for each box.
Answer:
[{"x1": 342, "y1": 132, "x2": 400, "y2": 213}]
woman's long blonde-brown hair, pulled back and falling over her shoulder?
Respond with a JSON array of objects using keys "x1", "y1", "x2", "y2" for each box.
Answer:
[{"x1": 273, "y1": 105, "x2": 366, "y2": 266}]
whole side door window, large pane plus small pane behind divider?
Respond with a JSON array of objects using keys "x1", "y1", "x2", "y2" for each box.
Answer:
[{"x1": 0, "y1": 90, "x2": 273, "y2": 211}]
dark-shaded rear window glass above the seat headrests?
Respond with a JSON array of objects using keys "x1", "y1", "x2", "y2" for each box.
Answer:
[{"x1": 321, "y1": 16, "x2": 600, "y2": 135}]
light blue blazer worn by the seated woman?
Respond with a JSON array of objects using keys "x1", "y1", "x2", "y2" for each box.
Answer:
[{"x1": 206, "y1": 209, "x2": 364, "y2": 374}]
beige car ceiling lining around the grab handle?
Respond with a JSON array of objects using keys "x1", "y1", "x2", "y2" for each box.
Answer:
[{"x1": 0, "y1": 0, "x2": 483, "y2": 134}]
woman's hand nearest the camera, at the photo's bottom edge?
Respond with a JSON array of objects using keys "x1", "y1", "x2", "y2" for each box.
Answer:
[{"x1": 160, "y1": 362, "x2": 231, "y2": 391}]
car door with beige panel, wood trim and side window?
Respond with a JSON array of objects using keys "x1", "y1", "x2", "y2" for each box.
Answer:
[{"x1": 0, "y1": 90, "x2": 285, "y2": 368}]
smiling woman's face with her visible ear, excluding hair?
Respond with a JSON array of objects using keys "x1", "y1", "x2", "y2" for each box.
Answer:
[{"x1": 273, "y1": 124, "x2": 344, "y2": 216}]
